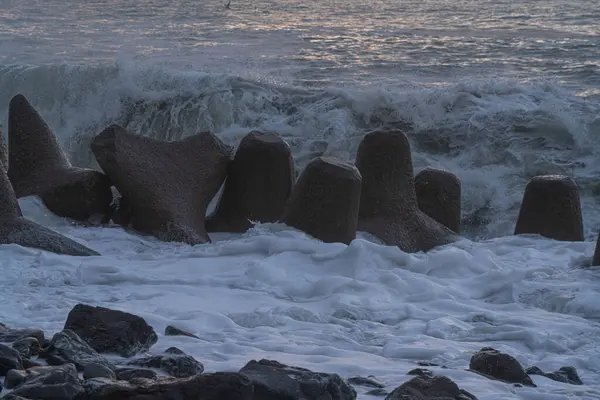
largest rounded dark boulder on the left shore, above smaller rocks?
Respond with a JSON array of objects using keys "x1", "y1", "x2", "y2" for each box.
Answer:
[{"x1": 64, "y1": 304, "x2": 158, "y2": 357}]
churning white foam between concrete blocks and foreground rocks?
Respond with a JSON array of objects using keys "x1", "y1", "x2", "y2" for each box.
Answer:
[{"x1": 0, "y1": 198, "x2": 600, "y2": 400}]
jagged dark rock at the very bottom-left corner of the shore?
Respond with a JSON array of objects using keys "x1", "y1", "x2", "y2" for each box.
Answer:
[{"x1": 12, "y1": 364, "x2": 85, "y2": 400}]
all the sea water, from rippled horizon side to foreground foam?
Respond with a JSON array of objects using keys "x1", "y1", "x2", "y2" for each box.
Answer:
[{"x1": 0, "y1": 0, "x2": 600, "y2": 400}]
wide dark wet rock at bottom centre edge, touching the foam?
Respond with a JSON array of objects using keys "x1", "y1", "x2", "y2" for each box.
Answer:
[{"x1": 240, "y1": 360, "x2": 356, "y2": 400}]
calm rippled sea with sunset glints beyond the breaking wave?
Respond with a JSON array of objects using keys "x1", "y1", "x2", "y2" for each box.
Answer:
[{"x1": 0, "y1": 0, "x2": 600, "y2": 94}]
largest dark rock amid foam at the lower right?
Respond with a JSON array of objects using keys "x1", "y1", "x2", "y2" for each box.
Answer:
[{"x1": 469, "y1": 347, "x2": 536, "y2": 387}]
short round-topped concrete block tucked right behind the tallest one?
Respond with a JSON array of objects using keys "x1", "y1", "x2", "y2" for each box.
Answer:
[{"x1": 415, "y1": 168, "x2": 461, "y2": 233}]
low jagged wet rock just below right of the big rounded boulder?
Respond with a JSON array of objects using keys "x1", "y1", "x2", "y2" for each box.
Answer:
[{"x1": 127, "y1": 347, "x2": 204, "y2": 378}]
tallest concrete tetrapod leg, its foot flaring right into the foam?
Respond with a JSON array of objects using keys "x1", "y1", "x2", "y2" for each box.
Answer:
[{"x1": 356, "y1": 130, "x2": 457, "y2": 253}]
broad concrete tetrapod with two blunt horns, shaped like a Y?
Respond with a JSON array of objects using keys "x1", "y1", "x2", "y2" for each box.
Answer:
[{"x1": 91, "y1": 125, "x2": 232, "y2": 245}]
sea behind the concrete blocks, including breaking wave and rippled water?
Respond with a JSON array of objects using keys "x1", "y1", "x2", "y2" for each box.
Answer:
[{"x1": 0, "y1": 0, "x2": 600, "y2": 240}]
